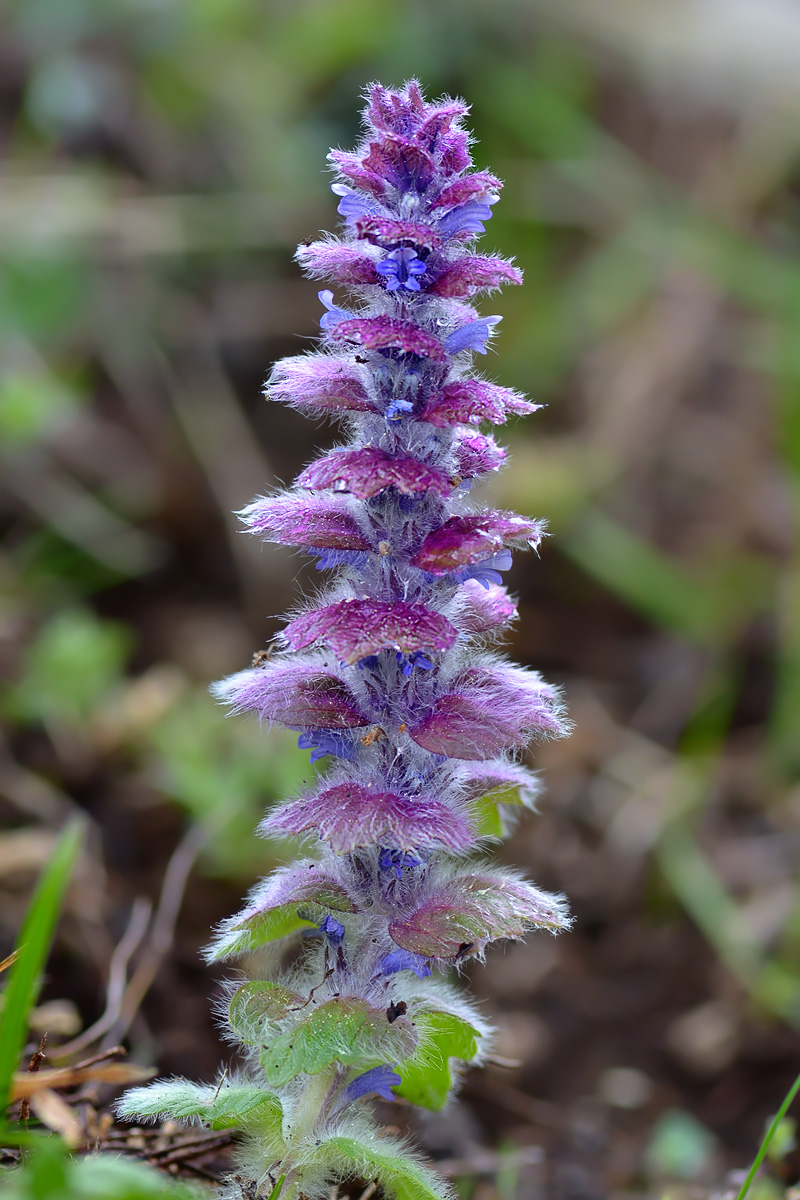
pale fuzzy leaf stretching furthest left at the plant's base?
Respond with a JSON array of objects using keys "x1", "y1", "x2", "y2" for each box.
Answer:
[{"x1": 118, "y1": 1079, "x2": 283, "y2": 1136}]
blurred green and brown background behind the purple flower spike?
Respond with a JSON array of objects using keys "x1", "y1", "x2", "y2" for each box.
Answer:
[{"x1": 0, "y1": 0, "x2": 800, "y2": 1196}]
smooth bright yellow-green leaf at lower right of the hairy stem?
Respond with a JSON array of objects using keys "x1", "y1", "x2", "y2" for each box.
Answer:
[{"x1": 395, "y1": 1013, "x2": 480, "y2": 1112}]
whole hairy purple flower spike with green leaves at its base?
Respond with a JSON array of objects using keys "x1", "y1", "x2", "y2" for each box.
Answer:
[{"x1": 120, "y1": 80, "x2": 569, "y2": 1200}]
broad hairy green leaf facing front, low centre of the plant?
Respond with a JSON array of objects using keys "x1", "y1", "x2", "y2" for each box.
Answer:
[{"x1": 261, "y1": 997, "x2": 416, "y2": 1087}]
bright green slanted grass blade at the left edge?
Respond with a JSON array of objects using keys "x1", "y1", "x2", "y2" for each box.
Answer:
[{"x1": 0, "y1": 821, "x2": 83, "y2": 1124}]
